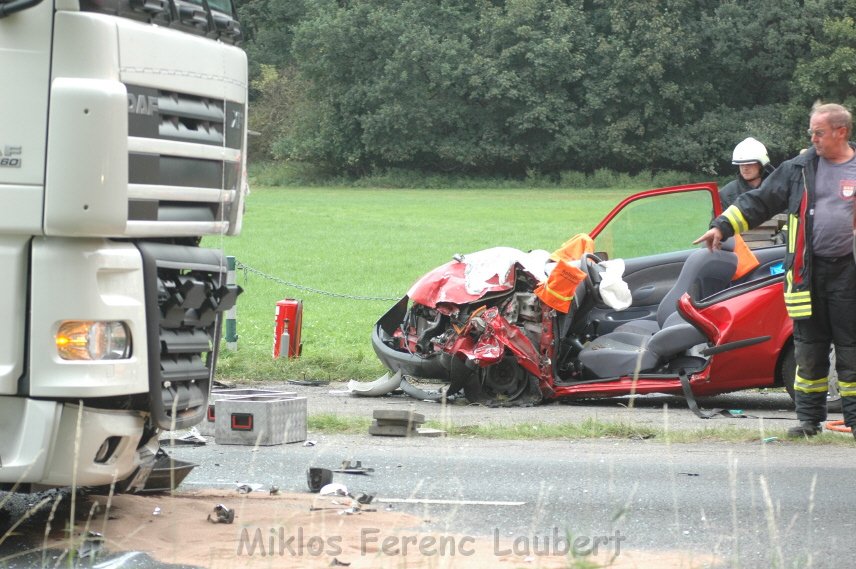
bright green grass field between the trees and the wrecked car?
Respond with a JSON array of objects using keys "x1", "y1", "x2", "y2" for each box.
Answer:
[{"x1": 204, "y1": 188, "x2": 699, "y2": 380}]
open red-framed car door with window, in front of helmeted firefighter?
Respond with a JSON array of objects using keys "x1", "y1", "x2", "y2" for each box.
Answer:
[{"x1": 589, "y1": 182, "x2": 722, "y2": 334}]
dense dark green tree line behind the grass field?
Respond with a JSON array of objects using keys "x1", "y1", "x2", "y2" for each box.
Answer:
[{"x1": 237, "y1": 0, "x2": 856, "y2": 176}]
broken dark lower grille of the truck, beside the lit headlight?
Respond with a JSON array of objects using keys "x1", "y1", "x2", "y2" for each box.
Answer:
[{"x1": 137, "y1": 242, "x2": 242, "y2": 430}]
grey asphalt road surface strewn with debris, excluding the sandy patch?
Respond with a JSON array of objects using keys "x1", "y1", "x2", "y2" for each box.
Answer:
[{"x1": 162, "y1": 388, "x2": 856, "y2": 568}]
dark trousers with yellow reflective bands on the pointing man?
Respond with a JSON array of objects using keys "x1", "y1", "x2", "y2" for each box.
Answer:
[{"x1": 794, "y1": 255, "x2": 856, "y2": 426}]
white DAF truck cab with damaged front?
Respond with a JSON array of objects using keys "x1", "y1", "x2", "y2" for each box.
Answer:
[{"x1": 0, "y1": 0, "x2": 247, "y2": 489}]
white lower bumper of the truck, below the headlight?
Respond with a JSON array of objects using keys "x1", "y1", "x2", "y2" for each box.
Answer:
[{"x1": 0, "y1": 397, "x2": 144, "y2": 486}]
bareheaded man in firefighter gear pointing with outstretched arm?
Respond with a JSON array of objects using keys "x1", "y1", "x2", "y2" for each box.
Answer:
[{"x1": 695, "y1": 104, "x2": 856, "y2": 437}]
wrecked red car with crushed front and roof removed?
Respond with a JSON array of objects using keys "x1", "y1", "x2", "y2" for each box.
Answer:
[{"x1": 372, "y1": 183, "x2": 836, "y2": 405}]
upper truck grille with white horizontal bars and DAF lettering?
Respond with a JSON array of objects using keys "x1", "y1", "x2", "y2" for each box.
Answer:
[{"x1": 126, "y1": 85, "x2": 245, "y2": 237}]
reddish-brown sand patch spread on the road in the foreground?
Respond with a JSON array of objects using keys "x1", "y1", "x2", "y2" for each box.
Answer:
[{"x1": 6, "y1": 490, "x2": 717, "y2": 569}]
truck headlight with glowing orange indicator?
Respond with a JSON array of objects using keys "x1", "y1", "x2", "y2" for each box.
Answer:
[{"x1": 55, "y1": 320, "x2": 131, "y2": 360}]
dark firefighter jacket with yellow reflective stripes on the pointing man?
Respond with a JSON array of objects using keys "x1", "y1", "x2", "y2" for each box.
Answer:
[{"x1": 710, "y1": 143, "x2": 856, "y2": 319}]
